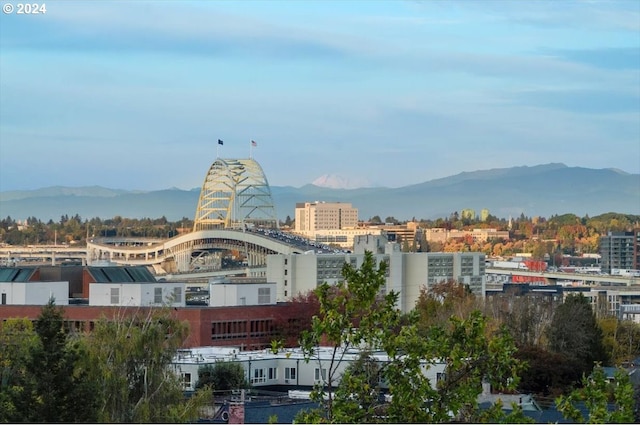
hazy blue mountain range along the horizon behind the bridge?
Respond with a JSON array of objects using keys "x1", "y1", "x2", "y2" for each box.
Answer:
[{"x1": 0, "y1": 164, "x2": 640, "y2": 221}]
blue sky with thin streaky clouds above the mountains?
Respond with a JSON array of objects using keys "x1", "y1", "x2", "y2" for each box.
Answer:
[{"x1": 0, "y1": 0, "x2": 640, "y2": 191}]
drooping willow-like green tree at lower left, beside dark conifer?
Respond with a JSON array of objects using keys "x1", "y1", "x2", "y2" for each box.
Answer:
[{"x1": 88, "y1": 308, "x2": 211, "y2": 423}]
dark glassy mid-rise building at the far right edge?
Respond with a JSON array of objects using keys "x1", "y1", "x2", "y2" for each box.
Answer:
[{"x1": 600, "y1": 229, "x2": 640, "y2": 273}]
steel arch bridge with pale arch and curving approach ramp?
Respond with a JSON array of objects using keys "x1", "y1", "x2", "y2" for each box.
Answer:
[{"x1": 87, "y1": 158, "x2": 313, "y2": 274}]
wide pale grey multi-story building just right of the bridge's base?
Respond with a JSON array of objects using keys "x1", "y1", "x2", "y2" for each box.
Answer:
[{"x1": 267, "y1": 236, "x2": 485, "y2": 312}]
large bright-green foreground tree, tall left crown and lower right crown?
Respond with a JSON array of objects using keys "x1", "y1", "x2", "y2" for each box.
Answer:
[{"x1": 296, "y1": 252, "x2": 521, "y2": 423}]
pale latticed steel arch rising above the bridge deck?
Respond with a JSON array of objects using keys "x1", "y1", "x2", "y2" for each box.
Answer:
[{"x1": 193, "y1": 158, "x2": 278, "y2": 231}]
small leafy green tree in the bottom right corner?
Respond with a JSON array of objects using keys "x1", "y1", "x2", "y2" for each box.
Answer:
[{"x1": 556, "y1": 367, "x2": 635, "y2": 424}]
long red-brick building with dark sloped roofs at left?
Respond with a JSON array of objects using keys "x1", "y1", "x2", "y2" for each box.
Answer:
[{"x1": 0, "y1": 266, "x2": 314, "y2": 350}]
